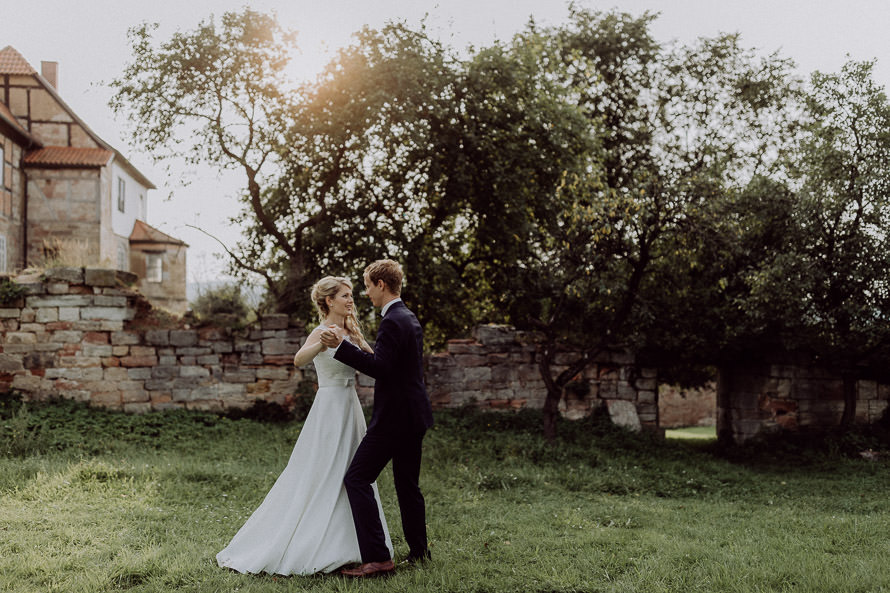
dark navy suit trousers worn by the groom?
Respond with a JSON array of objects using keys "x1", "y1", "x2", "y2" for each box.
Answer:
[{"x1": 343, "y1": 429, "x2": 427, "y2": 562}]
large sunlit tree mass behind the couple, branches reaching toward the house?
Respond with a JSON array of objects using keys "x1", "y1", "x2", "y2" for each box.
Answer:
[{"x1": 113, "y1": 10, "x2": 586, "y2": 343}]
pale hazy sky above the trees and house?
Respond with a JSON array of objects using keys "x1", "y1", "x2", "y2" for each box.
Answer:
[{"x1": 0, "y1": 0, "x2": 890, "y2": 282}]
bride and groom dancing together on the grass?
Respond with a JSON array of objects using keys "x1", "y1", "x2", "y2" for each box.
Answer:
[{"x1": 216, "y1": 260, "x2": 433, "y2": 577}]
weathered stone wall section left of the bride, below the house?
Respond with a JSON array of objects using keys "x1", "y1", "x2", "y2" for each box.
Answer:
[{"x1": 0, "y1": 268, "x2": 313, "y2": 413}]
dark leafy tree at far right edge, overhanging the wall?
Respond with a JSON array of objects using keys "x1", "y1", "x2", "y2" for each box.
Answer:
[{"x1": 640, "y1": 62, "x2": 890, "y2": 438}]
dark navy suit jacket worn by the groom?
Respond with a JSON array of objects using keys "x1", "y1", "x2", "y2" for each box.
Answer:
[{"x1": 334, "y1": 301, "x2": 433, "y2": 436}]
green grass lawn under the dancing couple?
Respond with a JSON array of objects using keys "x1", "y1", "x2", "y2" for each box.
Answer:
[{"x1": 0, "y1": 403, "x2": 890, "y2": 593}]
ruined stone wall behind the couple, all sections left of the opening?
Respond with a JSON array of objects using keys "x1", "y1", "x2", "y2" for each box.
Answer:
[{"x1": 0, "y1": 268, "x2": 658, "y2": 428}]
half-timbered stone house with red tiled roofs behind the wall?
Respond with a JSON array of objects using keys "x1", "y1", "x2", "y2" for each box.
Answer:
[{"x1": 0, "y1": 46, "x2": 188, "y2": 313}]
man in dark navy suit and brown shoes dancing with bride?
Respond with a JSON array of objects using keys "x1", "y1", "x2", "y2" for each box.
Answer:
[{"x1": 321, "y1": 259, "x2": 433, "y2": 577}]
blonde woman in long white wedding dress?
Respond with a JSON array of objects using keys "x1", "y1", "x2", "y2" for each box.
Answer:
[{"x1": 216, "y1": 276, "x2": 392, "y2": 575}]
